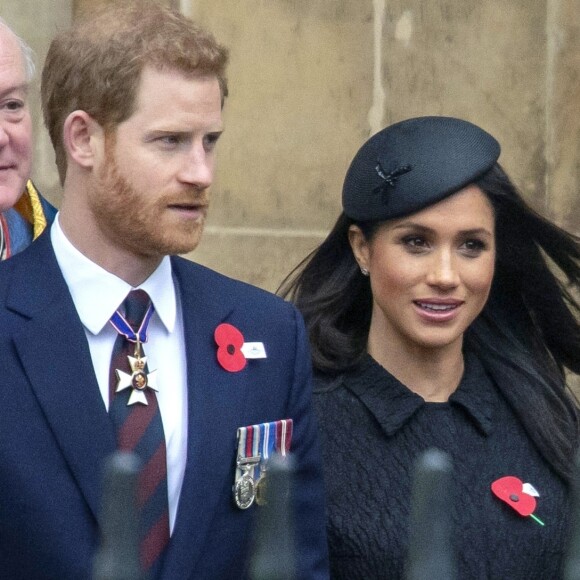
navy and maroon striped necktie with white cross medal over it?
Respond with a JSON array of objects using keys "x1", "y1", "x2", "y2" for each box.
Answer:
[{"x1": 109, "y1": 290, "x2": 169, "y2": 571}]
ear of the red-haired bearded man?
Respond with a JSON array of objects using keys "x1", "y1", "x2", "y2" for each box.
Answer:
[{"x1": 63, "y1": 111, "x2": 105, "y2": 169}]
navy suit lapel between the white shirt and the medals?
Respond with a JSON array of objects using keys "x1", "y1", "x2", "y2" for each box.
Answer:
[{"x1": 163, "y1": 261, "x2": 246, "y2": 578}]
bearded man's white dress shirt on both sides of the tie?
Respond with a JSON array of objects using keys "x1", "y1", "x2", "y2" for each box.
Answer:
[{"x1": 50, "y1": 215, "x2": 188, "y2": 532}]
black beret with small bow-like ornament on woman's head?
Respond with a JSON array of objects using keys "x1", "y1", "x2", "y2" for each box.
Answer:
[{"x1": 342, "y1": 117, "x2": 500, "y2": 221}]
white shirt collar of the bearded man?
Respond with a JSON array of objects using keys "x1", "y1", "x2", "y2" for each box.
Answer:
[{"x1": 50, "y1": 214, "x2": 177, "y2": 335}]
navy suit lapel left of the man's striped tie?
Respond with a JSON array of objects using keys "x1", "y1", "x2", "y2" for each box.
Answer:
[{"x1": 7, "y1": 233, "x2": 115, "y2": 517}]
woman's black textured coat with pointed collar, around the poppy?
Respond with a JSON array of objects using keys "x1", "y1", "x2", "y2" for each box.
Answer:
[{"x1": 314, "y1": 356, "x2": 568, "y2": 580}]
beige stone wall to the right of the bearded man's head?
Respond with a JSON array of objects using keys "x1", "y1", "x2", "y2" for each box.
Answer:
[{"x1": 40, "y1": 0, "x2": 580, "y2": 290}]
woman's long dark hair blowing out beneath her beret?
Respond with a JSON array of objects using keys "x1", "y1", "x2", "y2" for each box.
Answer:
[{"x1": 278, "y1": 164, "x2": 580, "y2": 480}]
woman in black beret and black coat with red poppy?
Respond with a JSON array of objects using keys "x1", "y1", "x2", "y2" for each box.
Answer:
[{"x1": 281, "y1": 117, "x2": 580, "y2": 580}]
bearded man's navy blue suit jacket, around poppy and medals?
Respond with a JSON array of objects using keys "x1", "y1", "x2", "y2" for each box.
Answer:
[{"x1": 0, "y1": 232, "x2": 328, "y2": 580}]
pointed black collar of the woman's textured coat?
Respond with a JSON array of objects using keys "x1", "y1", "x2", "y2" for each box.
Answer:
[{"x1": 344, "y1": 354, "x2": 497, "y2": 436}]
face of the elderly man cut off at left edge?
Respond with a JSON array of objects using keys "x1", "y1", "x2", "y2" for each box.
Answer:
[{"x1": 0, "y1": 25, "x2": 32, "y2": 211}]
